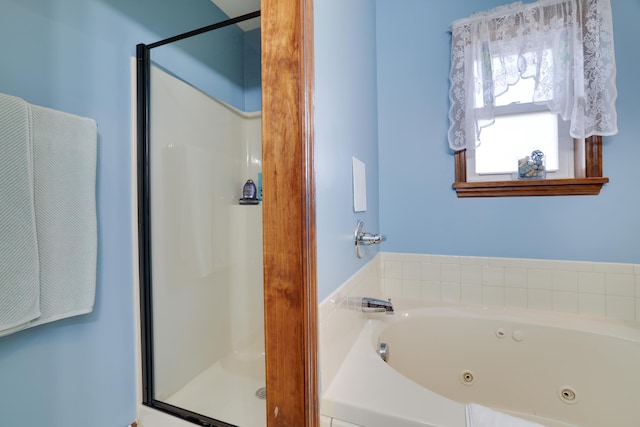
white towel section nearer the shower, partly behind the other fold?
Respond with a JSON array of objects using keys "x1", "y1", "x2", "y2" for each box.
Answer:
[{"x1": 29, "y1": 105, "x2": 98, "y2": 327}]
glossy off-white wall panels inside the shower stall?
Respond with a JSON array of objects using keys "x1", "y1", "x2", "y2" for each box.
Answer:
[{"x1": 150, "y1": 67, "x2": 264, "y2": 400}]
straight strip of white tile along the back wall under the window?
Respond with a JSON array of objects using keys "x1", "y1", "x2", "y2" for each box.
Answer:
[{"x1": 376, "y1": 252, "x2": 640, "y2": 321}]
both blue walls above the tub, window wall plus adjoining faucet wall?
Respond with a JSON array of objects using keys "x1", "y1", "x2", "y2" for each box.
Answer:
[{"x1": 314, "y1": 0, "x2": 640, "y2": 301}]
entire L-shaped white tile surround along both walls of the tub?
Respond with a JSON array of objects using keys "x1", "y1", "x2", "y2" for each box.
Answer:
[{"x1": 318, "y1": 252, "x2": 640, "y2": 385}]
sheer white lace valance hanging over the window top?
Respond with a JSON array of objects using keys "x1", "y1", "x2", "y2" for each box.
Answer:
[{"x1": 449, "y1": 0, "x2": 618, "y2": 150}]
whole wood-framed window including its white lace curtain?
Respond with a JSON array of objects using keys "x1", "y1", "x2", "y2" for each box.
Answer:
[{"x1": 449, "y1": 0, "x2": 617, "y2": 197}]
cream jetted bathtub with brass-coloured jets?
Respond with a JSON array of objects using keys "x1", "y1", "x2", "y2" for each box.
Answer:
[{"x1": 322, "y1": 299, "x2": 640, "y2": 427}]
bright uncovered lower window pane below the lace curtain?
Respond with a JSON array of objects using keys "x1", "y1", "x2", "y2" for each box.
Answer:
[{"x1": 475, "y1": 111, "x2": 558, "y2": 174}]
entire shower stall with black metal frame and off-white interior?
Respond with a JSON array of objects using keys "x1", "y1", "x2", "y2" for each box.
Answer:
[{"x1": 137, "y1": 12, "x2": 266, "y2": 427}]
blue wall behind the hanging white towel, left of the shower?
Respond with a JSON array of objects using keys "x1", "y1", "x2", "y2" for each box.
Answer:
[{"x1": 0, "y1": 0, "x2": 249, "y2": 427}]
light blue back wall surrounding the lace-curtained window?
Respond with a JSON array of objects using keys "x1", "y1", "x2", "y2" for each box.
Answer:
[{"x1": 377, "y1": 0, "x2": 640, "y2": 263}]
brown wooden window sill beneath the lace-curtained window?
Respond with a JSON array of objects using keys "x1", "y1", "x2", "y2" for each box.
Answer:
[{"x1": 453, "y1": 177, "x2": 609, "y2": 197}]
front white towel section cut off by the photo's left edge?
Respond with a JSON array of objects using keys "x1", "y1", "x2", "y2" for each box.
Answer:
[{"x1": 0, "y1": 94, "x2": 40, "y2": 336}]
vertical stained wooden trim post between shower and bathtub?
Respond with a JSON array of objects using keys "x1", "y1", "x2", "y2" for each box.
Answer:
[{"x1": 261, "y1": 0, "x2": 319, "y2": 427}]
